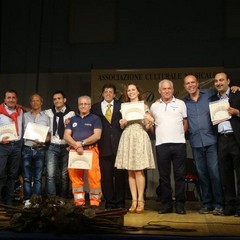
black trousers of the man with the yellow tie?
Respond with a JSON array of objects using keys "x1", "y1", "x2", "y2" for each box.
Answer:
[{"x1": 100, "y1": 155, "x2": 127, "y2": 208}]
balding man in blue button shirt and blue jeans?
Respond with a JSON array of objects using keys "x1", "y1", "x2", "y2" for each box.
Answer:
[{"x1": 184, "y1": 75, "x2": 223, "y2": 214}]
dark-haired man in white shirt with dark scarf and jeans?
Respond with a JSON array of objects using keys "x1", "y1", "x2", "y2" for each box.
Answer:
[{"x1": 45, "y1": 91, "x2": 75, "y2": 198}]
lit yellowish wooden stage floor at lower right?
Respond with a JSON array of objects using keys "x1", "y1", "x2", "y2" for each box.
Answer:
[{"x1": 124, "y1": 200, "x2": 240, "y2": 237}]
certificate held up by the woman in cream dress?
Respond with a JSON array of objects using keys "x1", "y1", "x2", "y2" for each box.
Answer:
[{"x1": 121, "y1": 101, "x2": 145, "y2": 121}]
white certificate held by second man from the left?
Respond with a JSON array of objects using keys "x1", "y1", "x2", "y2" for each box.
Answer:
[{"x1": 23, "y1": 122, "x2": 49, "y2": 142}]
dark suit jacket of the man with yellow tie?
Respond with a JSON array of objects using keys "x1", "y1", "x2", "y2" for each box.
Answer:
[{"x1": 91, "y1": 100, "x2": 122, "y2": 157}]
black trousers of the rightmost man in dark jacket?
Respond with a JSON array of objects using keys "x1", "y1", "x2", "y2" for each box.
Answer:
[{"x1": 218, "y1": 134, "x2": 240, "y2": 209}]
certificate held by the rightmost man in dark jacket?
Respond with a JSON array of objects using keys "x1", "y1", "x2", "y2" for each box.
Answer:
[{"x1": 209, "y1": 99, "x2": 231, "y2": 125}]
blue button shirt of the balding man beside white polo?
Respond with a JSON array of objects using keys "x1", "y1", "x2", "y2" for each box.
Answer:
[{"x1": 184, "y1": 89, "x2": 217, "y2": 148}]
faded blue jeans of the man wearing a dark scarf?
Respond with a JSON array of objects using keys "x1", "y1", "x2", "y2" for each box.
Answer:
[{"x1": 46, "y1": 144, "x2": 69, "y2": 198}]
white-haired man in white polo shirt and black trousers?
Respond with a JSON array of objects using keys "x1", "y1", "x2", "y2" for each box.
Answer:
[{"x1": 150, "y1": 79, "x2": 188, "y2": 214}]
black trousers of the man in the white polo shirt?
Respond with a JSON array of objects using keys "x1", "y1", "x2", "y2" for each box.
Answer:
[{"x1": 156, "y1": 143, "x2": 186, "y2": 203}]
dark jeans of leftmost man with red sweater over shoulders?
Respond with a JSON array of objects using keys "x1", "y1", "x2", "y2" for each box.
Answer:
[{"x1": 0, "y1": 141, "x2": 21, "y2": 205}]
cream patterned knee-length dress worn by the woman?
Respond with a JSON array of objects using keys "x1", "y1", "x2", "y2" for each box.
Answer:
[{"x1": 115, "y1": 120, "x2": 155, "y2": 170}]
